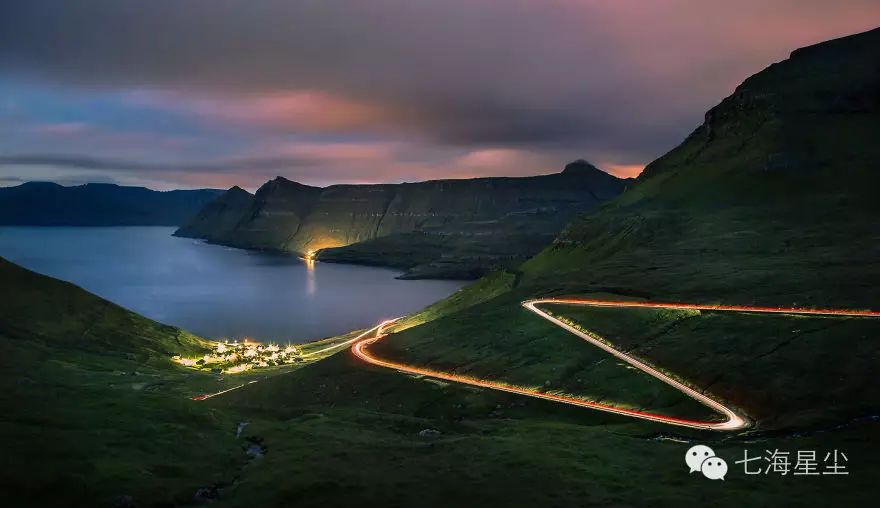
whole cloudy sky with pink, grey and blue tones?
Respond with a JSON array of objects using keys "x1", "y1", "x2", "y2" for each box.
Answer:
[{"x1": 0, "y1": 0, "x2": 880, "y2": 190}]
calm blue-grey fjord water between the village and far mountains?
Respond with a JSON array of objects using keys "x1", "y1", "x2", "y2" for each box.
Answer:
[{"x1": 0, "y1": 227, "x2": 463, "y2": 342}]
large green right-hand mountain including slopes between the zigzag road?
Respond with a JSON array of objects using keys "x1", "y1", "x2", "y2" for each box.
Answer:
[{"x1": 366, "y1": 29, "x2": 880, "y2": 432}]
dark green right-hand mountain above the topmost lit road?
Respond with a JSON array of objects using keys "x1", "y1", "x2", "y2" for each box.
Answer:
[{"x1": 523, "y1": 25, "x2": 880, "y2": 306}]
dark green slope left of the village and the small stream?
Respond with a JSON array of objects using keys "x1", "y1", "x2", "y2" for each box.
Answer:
[{"x1": 0, "y1": 259, "x2": 243, "y2": 506}]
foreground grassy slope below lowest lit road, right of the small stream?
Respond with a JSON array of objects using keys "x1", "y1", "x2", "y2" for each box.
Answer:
[{"x1": 209, "y1": 328, "x2": 880, "y2": 507}]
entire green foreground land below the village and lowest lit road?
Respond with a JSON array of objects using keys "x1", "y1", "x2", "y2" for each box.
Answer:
[{"x1": 0, "y1": 254, "x2": 880, "y2": 507}]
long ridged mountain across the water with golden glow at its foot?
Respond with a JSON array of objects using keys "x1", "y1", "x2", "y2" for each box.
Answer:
[{"x1": 175, "y1": 161, "x2": 628, "y2": 278}]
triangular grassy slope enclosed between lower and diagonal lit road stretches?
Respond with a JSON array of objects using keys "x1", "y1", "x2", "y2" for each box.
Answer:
[{"x1": 372, "y1": 295, "x2": 717, "y2": 419}]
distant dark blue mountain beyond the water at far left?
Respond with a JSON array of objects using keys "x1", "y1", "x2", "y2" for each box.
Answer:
[{"x1": 0, "y1": 182, "x2": 223, "y2": 226}]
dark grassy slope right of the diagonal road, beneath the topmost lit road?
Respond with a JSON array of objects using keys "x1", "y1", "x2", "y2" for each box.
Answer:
[{"x1": 536, "y1": 306, "x2": 880, "y2": 431}]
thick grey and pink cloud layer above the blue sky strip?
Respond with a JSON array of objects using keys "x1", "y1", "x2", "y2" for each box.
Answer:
[{"x1": 0, "y1": 0, "x2": 880, "y2": 187}]
